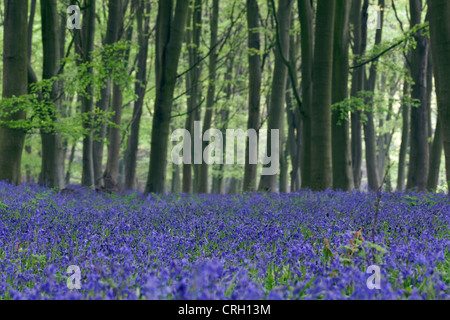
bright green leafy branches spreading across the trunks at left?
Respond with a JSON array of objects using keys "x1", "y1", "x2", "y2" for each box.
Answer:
[{"x1": 0, "y1": 41, "x2": 135, "y2": 140}]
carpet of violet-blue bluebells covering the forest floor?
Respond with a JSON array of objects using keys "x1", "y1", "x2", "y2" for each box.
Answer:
[{"x1": 0, "y1": 183, "x2": 450, "y2": 300}]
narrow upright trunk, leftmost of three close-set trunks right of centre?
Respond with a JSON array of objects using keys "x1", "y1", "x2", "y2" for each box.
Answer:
[{"x1": 298, "y1": 0, "x2": 314, "y2": 188}]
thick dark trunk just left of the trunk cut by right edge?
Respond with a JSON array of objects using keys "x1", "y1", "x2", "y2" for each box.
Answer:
[{"x1": 406, "y1": 0, "x2": 430, "y2": 191}]
